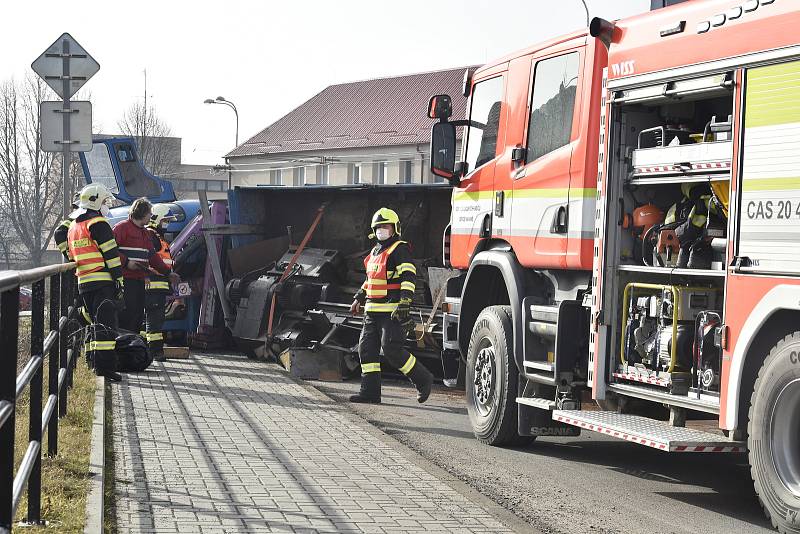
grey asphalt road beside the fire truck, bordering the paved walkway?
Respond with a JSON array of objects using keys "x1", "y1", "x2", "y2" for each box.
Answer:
[{"x1": 311, "y1": 380, "x2": 773, "y2": 534}]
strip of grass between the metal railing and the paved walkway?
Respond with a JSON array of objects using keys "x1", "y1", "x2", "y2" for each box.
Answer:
[{"x1": 14, "y1": 336, "x2": 95, "y2": 532}]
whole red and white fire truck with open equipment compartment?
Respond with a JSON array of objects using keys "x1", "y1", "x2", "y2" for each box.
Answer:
[{"x1": 429, "y1": 0, "x2": 800, "y2": 532}]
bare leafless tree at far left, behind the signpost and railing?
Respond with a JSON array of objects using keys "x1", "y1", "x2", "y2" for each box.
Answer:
[{"x1": 0, "y1": 76, "x2": 69, "y2": 266}]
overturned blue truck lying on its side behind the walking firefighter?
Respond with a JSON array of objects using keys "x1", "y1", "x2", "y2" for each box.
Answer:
[{"x1": 81, "y1": 138, "x2": 458, "y2": 378}]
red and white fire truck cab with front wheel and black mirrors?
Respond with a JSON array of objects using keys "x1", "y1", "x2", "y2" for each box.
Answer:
[{"x1": 429, "y1": 27, "x2": 606, "y2": 444}]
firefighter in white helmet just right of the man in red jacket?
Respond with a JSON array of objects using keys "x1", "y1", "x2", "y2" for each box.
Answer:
[{"x1": 144, "y1": 204, "x2": 178, "y2": 362}]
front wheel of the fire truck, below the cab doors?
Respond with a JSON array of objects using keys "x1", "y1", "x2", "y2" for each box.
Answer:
[{"x1": 465, "y1": 306, "x2": 530, "y2": 445}]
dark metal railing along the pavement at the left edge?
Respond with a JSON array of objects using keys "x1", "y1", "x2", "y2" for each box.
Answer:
[{"x1": 0, "y1": 263, "x2": 78, "y2": 533}]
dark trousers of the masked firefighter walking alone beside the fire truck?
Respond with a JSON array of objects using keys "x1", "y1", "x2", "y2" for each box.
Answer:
[{"x1": 358, "y1": 313, "x2": 421, "y2": 380}]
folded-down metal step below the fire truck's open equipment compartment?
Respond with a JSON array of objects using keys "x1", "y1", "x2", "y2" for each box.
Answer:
[{"x1": 553, "y1": 410, "x2": 747, "y2": 452}]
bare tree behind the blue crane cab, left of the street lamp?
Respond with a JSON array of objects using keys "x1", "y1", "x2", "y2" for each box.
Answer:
[{"x1": 117, "y1": 102, "x2": 180, "y2": 175}]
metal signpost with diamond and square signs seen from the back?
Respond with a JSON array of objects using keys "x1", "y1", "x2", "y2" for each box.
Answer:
[{"x1": 31, "y1": 33, "x2": 100, "y2": 217}]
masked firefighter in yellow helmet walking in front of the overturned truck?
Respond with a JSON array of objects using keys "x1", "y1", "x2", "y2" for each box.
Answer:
[{"x1": 350, "y1": 208, "x2": 433, "y2": 404}]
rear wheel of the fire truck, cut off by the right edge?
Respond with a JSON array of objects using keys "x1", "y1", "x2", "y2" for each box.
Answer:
[{"x1": 747, "y1": 332, "x2": 800, "y2": 534}]
